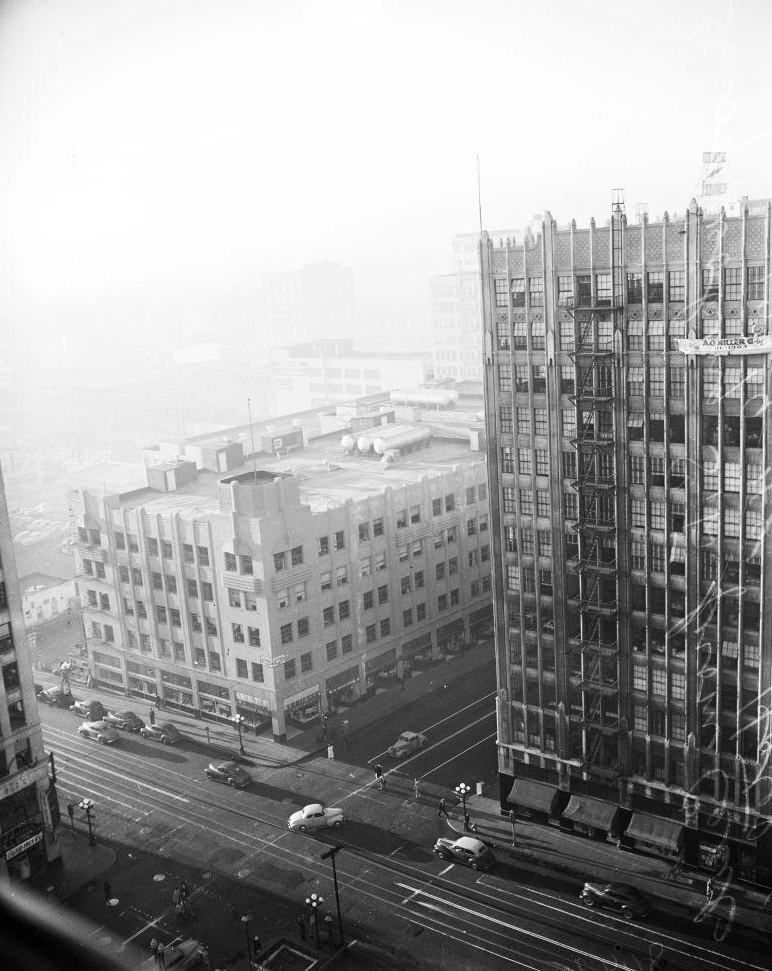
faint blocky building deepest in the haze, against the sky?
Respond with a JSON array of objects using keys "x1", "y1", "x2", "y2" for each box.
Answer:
[{"x1": 261, "y1": 260, "x2": 356, "y2": 347}]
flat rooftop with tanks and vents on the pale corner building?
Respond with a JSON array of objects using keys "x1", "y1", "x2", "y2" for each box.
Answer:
[{"x1": 114, "y1": 430, "x2": 485, "y2": 519}]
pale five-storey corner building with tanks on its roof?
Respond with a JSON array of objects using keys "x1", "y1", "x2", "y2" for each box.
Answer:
[{"x1": 70, "y1": 395, "x2": 491, "y2": 738}]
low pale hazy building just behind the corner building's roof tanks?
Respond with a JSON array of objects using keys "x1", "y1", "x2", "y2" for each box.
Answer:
[{"x1": 271, "y1": 338, "x2": 428, "y2": 415}]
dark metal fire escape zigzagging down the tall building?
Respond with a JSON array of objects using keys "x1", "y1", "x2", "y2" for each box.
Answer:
[{"x1": 571, "y1": 199, "x2": 624, "y2": 780}]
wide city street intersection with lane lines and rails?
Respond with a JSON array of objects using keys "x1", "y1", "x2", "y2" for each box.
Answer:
[{"x1": 33, "y1": 665, "x2": 765, "y2": 971}]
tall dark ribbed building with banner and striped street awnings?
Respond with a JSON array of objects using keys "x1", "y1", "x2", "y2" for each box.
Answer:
[{"x1": 481, "y1": 203, "x2": 772, "y2": 881}]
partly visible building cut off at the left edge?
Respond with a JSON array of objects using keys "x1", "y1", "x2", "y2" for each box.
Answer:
[{"x1": 0, "y1": 471, "x2": 60, "y2": 879}]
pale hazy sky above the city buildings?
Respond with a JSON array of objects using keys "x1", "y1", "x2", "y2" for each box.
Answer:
[{"x1": 0, "y1": 0, "x2": 772, "y2": 366}]
